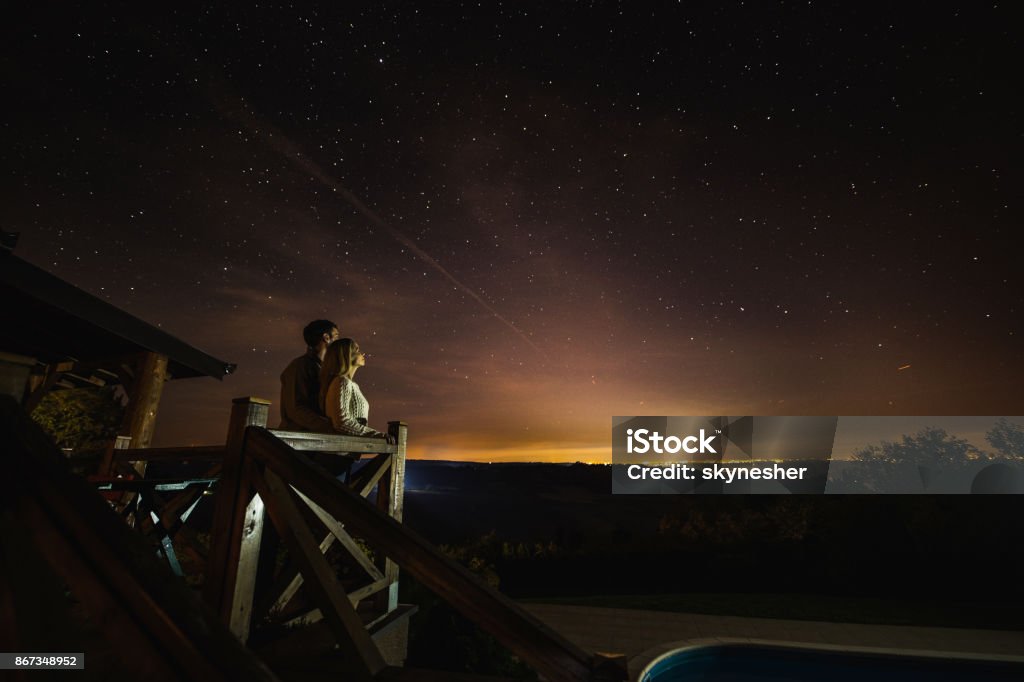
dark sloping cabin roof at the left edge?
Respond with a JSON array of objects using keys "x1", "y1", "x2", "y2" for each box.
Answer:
[{"x1": 0, "y1": 249, "x2": 237, "y2": 379}]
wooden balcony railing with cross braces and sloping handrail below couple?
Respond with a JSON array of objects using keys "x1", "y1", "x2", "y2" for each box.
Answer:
[{"x1": 0, "y1": 398, "x2": 626, "y2": 682}]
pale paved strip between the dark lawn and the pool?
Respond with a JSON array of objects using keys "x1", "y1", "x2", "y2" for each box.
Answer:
[{"x1": 522, "y1": 604, "x2": 1024, "y2": 674}]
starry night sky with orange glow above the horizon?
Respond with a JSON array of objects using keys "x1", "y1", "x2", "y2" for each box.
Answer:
[{"x1": 0, "y1": 2, "x2": 1024, "y2": 461}]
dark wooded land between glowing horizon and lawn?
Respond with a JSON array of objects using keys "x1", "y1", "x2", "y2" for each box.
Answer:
[{"x1": 406, "y1": 462, "x2": 1024, "y2": 607}]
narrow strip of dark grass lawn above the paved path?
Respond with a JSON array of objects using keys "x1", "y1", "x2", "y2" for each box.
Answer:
[{"x1": 520, "y1": 593, "x2": 1024, "y2": 630}]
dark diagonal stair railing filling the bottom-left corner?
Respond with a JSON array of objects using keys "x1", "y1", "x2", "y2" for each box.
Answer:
[{"x1": 0, "y1": 395, "x2": 279, "y2": 682}]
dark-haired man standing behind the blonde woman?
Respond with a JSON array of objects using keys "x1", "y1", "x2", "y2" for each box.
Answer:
[{"x1": 281, "y1": 319, "x2": 341, "y2": 433}]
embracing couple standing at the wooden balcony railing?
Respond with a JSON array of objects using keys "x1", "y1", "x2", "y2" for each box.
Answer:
[{"x1": 281, "y1": 319, "x2": 393, "y2": 442}]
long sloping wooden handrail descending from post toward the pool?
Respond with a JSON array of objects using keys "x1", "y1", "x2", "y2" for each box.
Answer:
[{"x1": 247, "y1": 428, "x2": 626, "y2": 682}]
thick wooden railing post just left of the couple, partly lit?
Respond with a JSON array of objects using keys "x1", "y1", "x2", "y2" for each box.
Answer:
[{"x1": 204, "y1": 397, "x2": 270, "y2": 642}]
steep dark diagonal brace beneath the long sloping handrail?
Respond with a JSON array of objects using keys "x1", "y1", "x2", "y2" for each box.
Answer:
[{"x1": 252, "y1": 470, "x2": 386, "y2": 680}]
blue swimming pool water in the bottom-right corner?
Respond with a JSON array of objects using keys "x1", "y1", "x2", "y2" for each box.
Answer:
[{"x1": 640, "y1": 644, "x2": 1024, "y2": 682}]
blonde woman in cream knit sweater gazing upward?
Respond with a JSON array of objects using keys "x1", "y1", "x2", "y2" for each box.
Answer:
[{"x1": 319, "y1": 339, "x2": 391, "y2": 442}]
